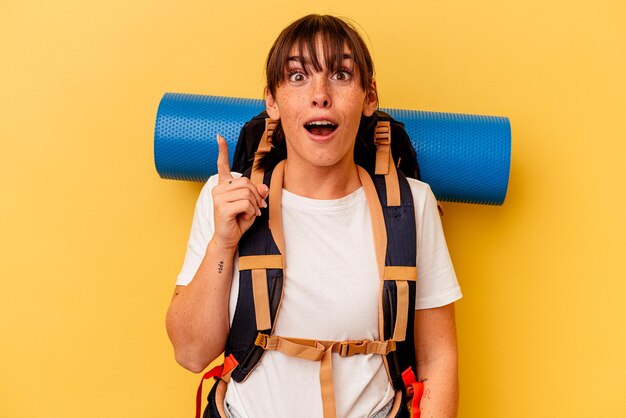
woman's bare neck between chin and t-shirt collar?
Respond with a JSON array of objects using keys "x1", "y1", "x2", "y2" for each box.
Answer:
[{"x1": 283, "y1": 158, "x2": 361, "y2": 200}]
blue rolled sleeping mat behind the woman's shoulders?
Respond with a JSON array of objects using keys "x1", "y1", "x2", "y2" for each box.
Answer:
[{"x1": 154, "y1": 93, "x2": 511, "y2": 205}]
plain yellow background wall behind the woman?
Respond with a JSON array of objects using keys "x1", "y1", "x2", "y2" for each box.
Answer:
[{"x1": 0, "y1": 0, "x2": 626, "y2": 418}]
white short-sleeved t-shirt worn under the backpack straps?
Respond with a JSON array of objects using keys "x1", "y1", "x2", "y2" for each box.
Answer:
[{"x1": 177, "y1": 173, "x2": 461, "y2": 418}]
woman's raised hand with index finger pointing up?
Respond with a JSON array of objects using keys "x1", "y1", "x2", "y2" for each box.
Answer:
[{"x1": 212, "y1": 135, "x2": 269, "y2": 250}]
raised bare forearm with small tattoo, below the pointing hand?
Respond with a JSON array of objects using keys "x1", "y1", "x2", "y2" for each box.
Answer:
[{"x1": 166, "y1": 241, "x2": 235, "y2": 372}]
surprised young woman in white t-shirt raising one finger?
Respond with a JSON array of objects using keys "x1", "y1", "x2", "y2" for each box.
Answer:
[{"x1": 167, "y1": 15, "x2": 461, "y2": 418}]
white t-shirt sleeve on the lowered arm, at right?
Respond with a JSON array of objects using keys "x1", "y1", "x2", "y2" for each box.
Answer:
[{"x1": 409, "y1": 179, "x2": 462, "y2": 309}]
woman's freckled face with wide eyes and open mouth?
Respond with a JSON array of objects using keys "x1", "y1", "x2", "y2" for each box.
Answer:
[{"x1": 266, "y1": 38, "x2": 378, "y2": 171}]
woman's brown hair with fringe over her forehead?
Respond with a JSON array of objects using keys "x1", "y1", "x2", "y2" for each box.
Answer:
[{"x1": 265, "y1": 15, "x2": 374, "y2": 96}]
